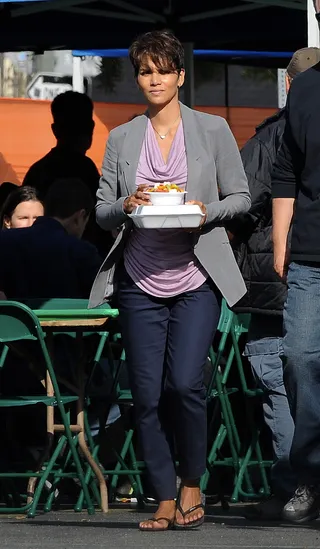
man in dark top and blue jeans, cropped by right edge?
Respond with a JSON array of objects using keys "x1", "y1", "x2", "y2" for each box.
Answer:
[{"x1": 272, "y1": 1, "x2": 320, "y2": 523}]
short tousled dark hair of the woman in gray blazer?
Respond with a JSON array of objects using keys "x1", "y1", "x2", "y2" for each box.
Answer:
[{"x1": 129, "y1": 30, "x2": 184, "y2": 76}]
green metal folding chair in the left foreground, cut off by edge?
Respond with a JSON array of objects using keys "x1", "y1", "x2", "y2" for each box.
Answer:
[{"x1": 0, "y1": 301, "x2": 94, "y2": 517}]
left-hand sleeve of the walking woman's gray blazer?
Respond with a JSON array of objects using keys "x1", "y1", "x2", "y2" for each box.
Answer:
[{"x1": 96, "y1": 132, "x2": 128, "y2": 231}]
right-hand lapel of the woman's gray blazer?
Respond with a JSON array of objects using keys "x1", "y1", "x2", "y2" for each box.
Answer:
[{"x1": 180, "y1": 103, "x2": 202, "y2": 200}]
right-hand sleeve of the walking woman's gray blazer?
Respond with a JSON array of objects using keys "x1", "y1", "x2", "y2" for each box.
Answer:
[{"x1": 206, "y1": 118, "x2": 251, "y2": 224}]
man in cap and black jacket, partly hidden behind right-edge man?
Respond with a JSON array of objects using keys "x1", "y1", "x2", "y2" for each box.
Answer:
[{"x1": 229, "y1": 48, "x2": 320, "y2": 519}]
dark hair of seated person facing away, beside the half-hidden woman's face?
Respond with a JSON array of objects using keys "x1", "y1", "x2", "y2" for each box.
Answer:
[{"x1": 44, "y1": 178, "x2": 94, "y2": 219}]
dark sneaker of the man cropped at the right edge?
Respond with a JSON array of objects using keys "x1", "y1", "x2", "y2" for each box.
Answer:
[{"x1": 282, "y1": 486, "x2": 320, "y2": 524}]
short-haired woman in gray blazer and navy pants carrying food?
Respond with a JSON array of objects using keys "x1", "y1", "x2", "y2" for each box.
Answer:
[{"x1": 89, "y1": 27, "x2": 250, "y2": 532}]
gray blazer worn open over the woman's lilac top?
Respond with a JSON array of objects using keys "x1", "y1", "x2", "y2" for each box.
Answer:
[{"x1": 89, "y1": 104, "x2": 251, "y2": 307}]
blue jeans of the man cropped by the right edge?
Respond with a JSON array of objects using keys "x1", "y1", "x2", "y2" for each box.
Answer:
[{"x1": 284, "y1": 262, "x2": 320, "y2": 485}]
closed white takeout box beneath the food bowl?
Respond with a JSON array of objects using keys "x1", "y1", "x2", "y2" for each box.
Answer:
[{"x1": 129, "y1": 204, "x2": 204, "y2": 229}]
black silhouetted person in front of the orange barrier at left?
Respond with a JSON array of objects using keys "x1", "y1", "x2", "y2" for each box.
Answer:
[{"x1": 23, "y1": 91, "x2": 113, "y2": 254}]
